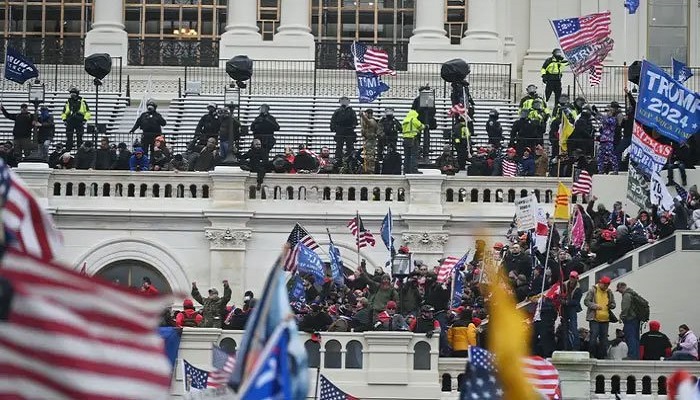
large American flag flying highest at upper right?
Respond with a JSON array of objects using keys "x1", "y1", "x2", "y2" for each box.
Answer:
[{"x1": 552, "y1": 11, "x2": 611, "y2": 51}]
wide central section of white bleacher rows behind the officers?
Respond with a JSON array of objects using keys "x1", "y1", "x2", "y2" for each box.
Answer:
[{"x1": 166, "y1": 95, "x2": 517, "y2": 159}]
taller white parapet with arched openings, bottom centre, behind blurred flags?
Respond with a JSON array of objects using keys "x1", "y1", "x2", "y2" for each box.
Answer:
[{"x1": 171, "y1": 328, "x2": 440, "y2": 399}]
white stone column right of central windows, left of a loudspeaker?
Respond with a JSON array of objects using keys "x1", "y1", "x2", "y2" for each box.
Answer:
[{"x1": 408, "y1": 0, "x2": 454, "y2": 62}]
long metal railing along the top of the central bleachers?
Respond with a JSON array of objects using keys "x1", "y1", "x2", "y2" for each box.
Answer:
[{"x1": 184, "y1": 60, "x2": 512, "y2": 99}]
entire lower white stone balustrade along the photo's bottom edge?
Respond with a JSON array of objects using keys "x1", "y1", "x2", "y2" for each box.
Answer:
[{"x1": 172, "y1": 328, "x2": 700, "y2": 400}]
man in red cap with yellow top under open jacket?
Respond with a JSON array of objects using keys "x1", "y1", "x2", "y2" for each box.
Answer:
[{"x1": 583, "y1": 276, "x2": 617, "y2": 360}]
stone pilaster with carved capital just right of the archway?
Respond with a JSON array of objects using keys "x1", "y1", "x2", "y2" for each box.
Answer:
[{"x1": 204, "y1": 228, "x2": 252, "y2": 302}]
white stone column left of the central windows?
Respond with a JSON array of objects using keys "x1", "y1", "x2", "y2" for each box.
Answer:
[{"x1": 273, "y1": 0, "x2": 316, "y2": 61}]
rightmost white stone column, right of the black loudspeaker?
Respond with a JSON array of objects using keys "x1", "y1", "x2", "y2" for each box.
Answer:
[{"x1": 462, "y1": 0, "x2": 503, "y2": 62}]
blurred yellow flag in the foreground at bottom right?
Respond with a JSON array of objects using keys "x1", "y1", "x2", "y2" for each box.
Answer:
[{"x1": 488, "y1": 271, "x2": 541, "y2": 400}]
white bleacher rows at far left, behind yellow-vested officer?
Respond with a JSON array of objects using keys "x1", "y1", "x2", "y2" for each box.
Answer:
[{"x1": 0, "y1": 91, "x2": 129, "y2": 148}]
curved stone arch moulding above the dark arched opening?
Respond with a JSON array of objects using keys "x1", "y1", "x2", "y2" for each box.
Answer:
[{"x1": 76, "y1": 238, "x2": 190, "y2": 293}]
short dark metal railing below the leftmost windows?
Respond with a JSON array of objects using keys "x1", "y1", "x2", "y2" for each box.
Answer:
[{"x1": 0, "y1": 38, "x2": 125, "y2": 93}]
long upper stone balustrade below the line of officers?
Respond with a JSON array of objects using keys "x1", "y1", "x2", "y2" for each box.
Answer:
[{"x1": 15, "y1": 163, "x2": 576, "y2": 218}]
